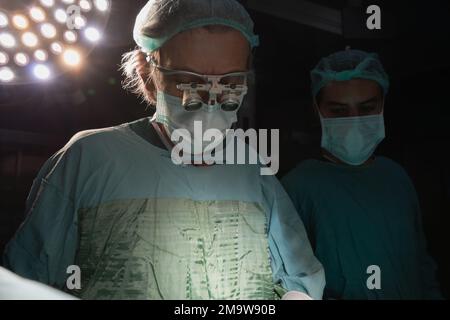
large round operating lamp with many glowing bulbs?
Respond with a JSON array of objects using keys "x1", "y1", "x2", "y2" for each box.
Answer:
[{"x1": 0, "y1": 0, "x2": 111, "y2": 85}]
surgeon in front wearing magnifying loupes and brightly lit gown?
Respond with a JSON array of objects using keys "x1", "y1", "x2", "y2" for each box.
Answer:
[{"x1": 5, "y1": 0, "x2": 325, "y2": 300}]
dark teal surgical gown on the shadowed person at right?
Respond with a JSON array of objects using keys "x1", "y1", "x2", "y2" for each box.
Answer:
[{"x1": 282, "y1": 157, "x2": 440, "y2": 299}]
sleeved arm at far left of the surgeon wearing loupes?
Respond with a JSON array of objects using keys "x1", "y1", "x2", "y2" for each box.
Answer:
[{"x1": 4, "y1": 145, "x2": 77, "y2": 288}]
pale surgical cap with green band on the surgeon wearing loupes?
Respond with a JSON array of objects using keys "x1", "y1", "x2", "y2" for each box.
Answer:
[{"x1": 133, "y1": 0, "x2": 259, "y2": 52}]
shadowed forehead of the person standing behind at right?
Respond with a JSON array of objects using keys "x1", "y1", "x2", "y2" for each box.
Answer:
[{"x1": 321, "y1": 79, "x2": 382, "y2": 102}]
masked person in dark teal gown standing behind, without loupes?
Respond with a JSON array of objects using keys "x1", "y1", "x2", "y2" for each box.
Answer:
[{"x1": 282, "y1": 50, "x2": 441, "y2": 299}]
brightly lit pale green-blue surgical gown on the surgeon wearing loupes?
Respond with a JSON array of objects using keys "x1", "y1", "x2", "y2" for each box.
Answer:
[{"x1": 5, "y1": 118, "x2": 325, "y2": 300}]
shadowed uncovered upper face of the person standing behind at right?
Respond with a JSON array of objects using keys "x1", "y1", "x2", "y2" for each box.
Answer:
[{"x1": 317, "y1": 79, "x2": 384, "y2": 118}]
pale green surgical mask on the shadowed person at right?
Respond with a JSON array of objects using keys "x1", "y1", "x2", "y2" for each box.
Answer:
[{"x1": 320, "y1": 114, "x2": 385, "y2": 166}]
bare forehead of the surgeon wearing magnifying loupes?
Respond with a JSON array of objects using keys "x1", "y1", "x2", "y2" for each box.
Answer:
[{"x1": 160, "y1": 28, "x2": 250, "y2": 75}]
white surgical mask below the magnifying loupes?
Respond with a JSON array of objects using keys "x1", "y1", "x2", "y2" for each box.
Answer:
[{"x1": 154, "y1": 91, "x2": 238, "y2": 154}]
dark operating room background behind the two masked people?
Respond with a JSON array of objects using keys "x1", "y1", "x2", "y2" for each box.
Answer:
[{"x1": 0, "y1": 0, "x2": 450, "y2": 297}]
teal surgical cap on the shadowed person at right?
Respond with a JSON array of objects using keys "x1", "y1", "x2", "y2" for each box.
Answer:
[{"x1": 311, "y1": 50, "x2": 389, "y2": 97}]
